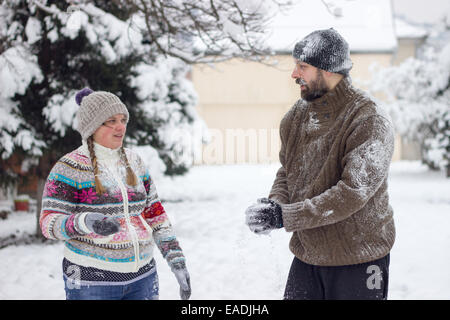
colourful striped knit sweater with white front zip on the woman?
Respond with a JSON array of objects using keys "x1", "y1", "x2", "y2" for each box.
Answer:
[{"x1": 39, "y1": 143, "x2": 185, "y2": 272}]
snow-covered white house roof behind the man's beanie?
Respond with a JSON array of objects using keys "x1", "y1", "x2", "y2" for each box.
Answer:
[{"x1": 267, "y1": 0, "x2": 397, "y2": 53}]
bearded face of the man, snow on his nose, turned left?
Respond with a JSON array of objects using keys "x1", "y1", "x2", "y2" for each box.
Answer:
[{"x1": 291, "y1": 60, "x2": 328, "y2": 101}]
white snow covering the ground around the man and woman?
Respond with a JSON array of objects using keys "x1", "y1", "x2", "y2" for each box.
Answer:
[{"x1": 0, "y1": 161, "x2": 450, "y2": 300}]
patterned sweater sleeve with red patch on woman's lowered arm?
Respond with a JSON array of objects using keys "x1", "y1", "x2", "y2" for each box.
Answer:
[{"x1": 143, "y1": 174, "x2": 186, "y2": 270}]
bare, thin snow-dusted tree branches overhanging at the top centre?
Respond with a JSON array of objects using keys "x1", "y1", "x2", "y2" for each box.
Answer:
[{"x1": 126, "y1": 0, "x2": 290, "y2": 63}]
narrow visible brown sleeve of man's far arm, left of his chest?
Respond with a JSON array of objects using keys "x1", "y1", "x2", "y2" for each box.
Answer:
[{"x1": 269, "y1": 109, "x2": 294, "y2": 204}]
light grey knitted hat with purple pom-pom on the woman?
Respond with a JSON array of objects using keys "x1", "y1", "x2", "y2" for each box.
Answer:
[{"x1": 75, "y1": 88, "x2": 129, "y2": 140}]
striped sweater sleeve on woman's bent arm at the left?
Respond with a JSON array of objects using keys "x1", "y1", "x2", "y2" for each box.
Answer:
[{"x1": 39, "y1": 161, "x2": 89, "y2": 240}]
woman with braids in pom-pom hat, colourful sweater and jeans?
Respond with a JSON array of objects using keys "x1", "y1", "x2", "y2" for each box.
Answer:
[{"x1": 39, "y1": 88, "x2": 191, "y2": 300}]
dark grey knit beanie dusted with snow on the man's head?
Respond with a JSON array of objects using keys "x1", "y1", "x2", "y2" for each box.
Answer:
[{"x1": 292, "y1": 28, "x2": 353, "y2": 76}]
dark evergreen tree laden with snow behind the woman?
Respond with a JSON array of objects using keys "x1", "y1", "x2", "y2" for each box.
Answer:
[{"x1": 0, "y1": 0, "x2": 201, "y2": 235}]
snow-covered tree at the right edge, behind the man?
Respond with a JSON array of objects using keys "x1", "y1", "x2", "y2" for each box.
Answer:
[{"x1": 371, "y1": 23, "x2": 450, "y2": 177}]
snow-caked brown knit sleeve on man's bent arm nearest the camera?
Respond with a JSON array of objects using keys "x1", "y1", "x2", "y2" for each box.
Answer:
[{"x1": 282, "y1": 115, "x2": 394, "y2": 231}]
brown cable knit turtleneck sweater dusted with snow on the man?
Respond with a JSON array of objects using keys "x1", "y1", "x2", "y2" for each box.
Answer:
[{"x1": 269, "y1": 77, "x2": 395, "y2": 266}]
